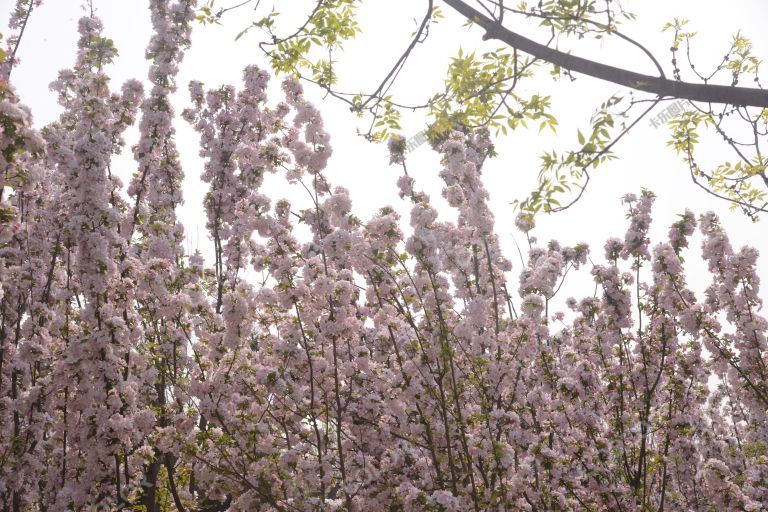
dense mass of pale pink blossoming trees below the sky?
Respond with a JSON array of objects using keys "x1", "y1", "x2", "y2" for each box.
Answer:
[{"x1": 0, "y1": 0, "x2": 768, "y2": 512}]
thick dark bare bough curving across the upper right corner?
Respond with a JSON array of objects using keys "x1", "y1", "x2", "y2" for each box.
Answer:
[{"x1": 445, "y1": 0, "x2": 768, "y2": 108}]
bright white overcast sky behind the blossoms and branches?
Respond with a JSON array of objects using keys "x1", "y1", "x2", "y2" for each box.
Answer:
[{"x1": 0, "y1": 0, "x2": 768, "y2": 302}]
